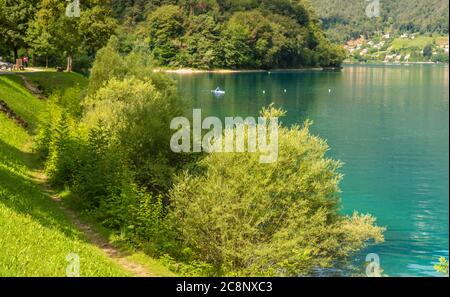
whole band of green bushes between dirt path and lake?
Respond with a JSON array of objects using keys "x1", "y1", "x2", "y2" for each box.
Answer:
[{"x1": 0, "y1": 38, "x2": 385, "y2": 276}]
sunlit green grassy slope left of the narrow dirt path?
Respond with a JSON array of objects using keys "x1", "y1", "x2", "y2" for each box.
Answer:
[{"x1": 0, "y1": 76, "x2": 128, "y2": 276}]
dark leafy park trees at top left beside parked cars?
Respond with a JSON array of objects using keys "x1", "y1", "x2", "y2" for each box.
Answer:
[{"x1": 0, "y1": 0, "x2": 117, "y2": 73}]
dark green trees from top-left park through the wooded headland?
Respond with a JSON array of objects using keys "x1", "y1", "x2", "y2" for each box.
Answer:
[{"x1": 0, "y1": 0, "x2": 345, "y2": 72}]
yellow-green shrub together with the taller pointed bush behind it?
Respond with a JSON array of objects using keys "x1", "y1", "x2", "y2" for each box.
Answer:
[{"x1": 82, "y1": 38, "x2": 183, "y2": 191}]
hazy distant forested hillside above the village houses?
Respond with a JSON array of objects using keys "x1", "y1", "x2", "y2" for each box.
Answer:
[{"x1": 310, "y1": 0, "x2": 449, "y2": 42}]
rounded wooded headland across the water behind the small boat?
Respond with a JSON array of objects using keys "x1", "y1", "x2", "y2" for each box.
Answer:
[{"x1": 112, "y1": 0, "x2": 344, "y2": 69}]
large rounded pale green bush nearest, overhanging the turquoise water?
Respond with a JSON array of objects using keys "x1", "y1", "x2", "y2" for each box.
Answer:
[{"x1": 169, "y1": 109, "x2": 383, "y2": 276}]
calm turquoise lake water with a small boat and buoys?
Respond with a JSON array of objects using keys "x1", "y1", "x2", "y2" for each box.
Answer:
[{"x1": 174, "y1": 65, "x2": 449, "y2": 276}]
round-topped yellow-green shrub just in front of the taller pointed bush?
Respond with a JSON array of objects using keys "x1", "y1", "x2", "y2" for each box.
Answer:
[{"x1": 83, "y1": 77, "x2": 182, "y2": 191}]
